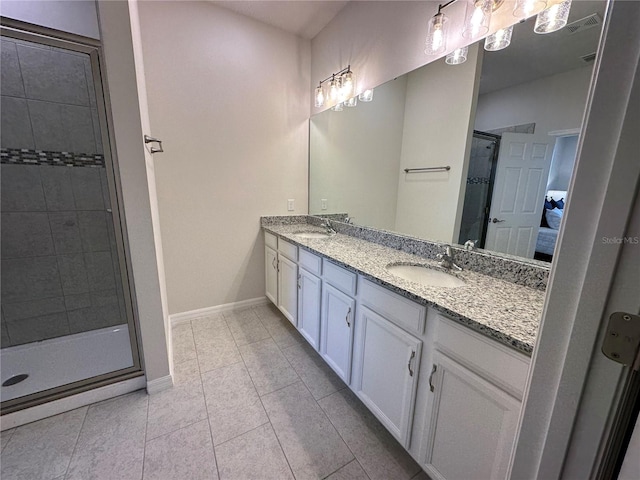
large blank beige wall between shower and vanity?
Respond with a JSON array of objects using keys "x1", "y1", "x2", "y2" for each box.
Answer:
[{"x1": 139, "y1": 1, "x2": 311, "y2": 313}]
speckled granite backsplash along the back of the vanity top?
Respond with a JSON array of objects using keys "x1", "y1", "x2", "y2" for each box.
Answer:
[{"x1": 260, "y1": 215, "x2": 550, "y2": 290}]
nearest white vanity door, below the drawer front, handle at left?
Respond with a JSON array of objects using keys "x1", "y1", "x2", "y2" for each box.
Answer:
[{"x1": 423, "y1": 350, "x2": 520, "y2": 480}]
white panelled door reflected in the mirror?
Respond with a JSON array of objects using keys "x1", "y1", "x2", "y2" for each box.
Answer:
[{"x1": 485, "y1": 133, "x2": 555, "y2": 258}]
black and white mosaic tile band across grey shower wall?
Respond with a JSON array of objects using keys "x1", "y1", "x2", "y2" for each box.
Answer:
[{"x1": 0, "y1": 148, "x2": 105, "y2": 168}]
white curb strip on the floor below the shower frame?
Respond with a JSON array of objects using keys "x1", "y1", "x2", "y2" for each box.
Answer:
[{"x1": 2, "y1": 375, "x2": 147, "y2": 430}]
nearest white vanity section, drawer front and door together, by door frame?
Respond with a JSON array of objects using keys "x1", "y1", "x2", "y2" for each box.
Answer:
[{"x1": 420, "y1": 311, "x2": 529, "y2": 480}]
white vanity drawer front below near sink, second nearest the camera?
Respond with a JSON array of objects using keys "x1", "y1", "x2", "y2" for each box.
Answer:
[{"x1": 360, "y1": 278, "x2": 427, "y2": 335}]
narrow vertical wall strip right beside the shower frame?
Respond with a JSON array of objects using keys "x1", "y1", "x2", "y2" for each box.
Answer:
[{"x1": 99, "y1": 0, "x2": 169, "y2": 381}]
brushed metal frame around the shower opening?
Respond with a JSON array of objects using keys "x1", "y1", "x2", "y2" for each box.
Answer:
[{"x1": 0, "y1": 17, "x2": 144, "y2": 415}]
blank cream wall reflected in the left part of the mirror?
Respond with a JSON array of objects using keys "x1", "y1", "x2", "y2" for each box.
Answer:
[{"x1": 309, "y1": 76, "x2": 407, "y2": 230}]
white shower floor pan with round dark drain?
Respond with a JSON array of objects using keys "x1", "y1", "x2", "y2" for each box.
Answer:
[{"x1": 0, "y1": 324, "x2": 133, "y2": 402}]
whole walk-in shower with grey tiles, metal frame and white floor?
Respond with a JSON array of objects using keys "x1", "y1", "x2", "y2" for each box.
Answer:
[{"x1": 0, "y1": 20, "x2": 140, "y2": 413}]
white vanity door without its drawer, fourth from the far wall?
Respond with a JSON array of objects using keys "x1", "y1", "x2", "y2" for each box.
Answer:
[{"x1": 320, "y1": 282, "x2": 355, "y2": 384}]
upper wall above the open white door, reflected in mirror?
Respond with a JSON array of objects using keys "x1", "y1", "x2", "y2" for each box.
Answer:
[{"x1": 475, "y1": 66, "x2": 593, "y2": 133}]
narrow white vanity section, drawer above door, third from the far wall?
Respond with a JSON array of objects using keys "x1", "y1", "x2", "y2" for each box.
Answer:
[{"x1": 298, "y1": 249, "x2": 322, "y2": 350}]
